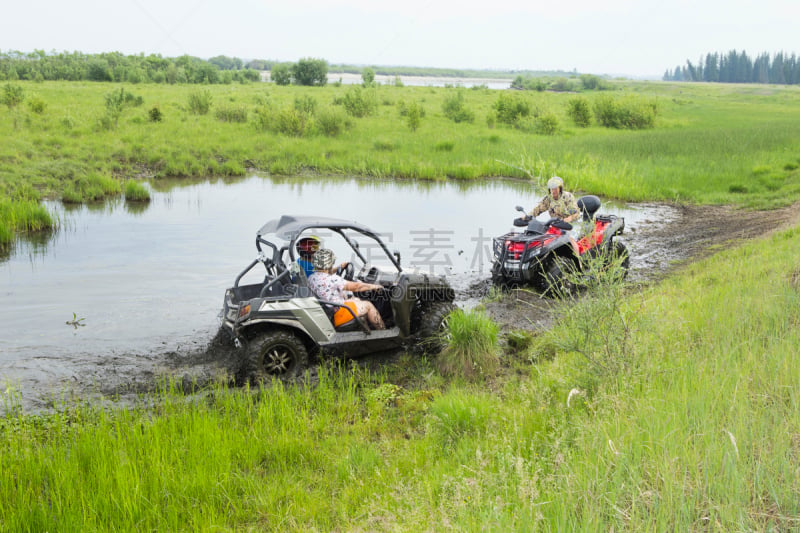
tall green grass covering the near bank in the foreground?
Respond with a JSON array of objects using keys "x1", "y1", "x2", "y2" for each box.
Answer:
[{"x1": 0, "y1": 221, "x2": 800, "y2": 531}]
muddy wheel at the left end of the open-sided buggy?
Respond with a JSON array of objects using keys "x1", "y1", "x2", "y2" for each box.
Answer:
[{"x1": 244, "y1": 331, "x2": 308, "y2": 382}]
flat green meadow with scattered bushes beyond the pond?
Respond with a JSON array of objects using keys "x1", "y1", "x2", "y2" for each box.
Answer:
[{"x1": 0, "y1": 82, "x2": 800, "y2": 248}]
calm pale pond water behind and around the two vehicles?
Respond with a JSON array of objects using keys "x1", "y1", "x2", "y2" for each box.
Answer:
[{"x1": 0, "y1": 176, "x2": 669, "y2": 404}]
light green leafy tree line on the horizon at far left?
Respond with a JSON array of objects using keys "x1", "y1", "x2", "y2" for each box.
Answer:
[{"x1": 0, "y1": 50, "x2": 274, "y2": 83}]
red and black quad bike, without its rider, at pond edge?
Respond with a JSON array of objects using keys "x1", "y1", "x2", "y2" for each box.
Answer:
[{"x1": 492, "y1": 195, "x2": 630, "y2": 292}]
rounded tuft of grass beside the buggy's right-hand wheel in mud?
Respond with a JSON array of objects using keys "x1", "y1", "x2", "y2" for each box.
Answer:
[{"x1": 436, "y1": 309, "x2": 500, "y2": 379}]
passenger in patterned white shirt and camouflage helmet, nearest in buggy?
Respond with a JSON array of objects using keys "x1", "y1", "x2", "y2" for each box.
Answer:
[{"x1": 308, "y1": 248, "x2": 386, "y2": 329}]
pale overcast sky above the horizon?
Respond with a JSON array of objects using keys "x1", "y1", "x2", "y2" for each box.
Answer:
[{"x1": 0, "y1": 0, "x2": 800, "y2": 78}]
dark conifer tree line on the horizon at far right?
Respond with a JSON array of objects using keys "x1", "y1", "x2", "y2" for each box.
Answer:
[{"x1": 663, "y1": 50, "x2": 800, "y2": 85}]
